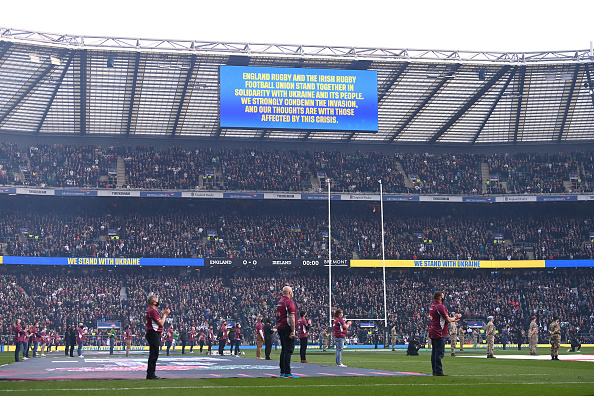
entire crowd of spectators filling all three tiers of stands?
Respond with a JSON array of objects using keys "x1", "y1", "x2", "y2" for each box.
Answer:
[{"x1": 0, "y1": 142, "x2": 594, "y2": 350}]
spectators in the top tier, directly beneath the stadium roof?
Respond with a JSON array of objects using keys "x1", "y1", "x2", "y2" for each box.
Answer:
[{"x1": 0, "y1": 142, "x2": 594, "y2": 195}]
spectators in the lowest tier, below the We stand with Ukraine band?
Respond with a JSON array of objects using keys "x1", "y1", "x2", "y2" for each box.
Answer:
[{"x1": 0, "y1": 266, "x2": 594, "y2": 343}]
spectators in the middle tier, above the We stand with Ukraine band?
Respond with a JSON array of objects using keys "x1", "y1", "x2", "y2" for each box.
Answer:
[{"x1": 0, "y1": 197, "x2": 594, "y2": 260}]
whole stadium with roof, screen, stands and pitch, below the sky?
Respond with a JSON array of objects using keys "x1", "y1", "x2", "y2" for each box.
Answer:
[{"x1": 0, "y1": 17, "x2": 594, "y2": 395}]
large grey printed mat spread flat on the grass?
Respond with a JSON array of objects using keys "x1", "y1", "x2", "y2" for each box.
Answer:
[{"x1": 0, "y1": 355, "x2": 425, "y2": 381}]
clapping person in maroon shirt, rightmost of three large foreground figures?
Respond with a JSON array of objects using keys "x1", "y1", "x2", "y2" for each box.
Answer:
[{"x1": 429, "y1": 291, "x2": 462, "y2": 376}]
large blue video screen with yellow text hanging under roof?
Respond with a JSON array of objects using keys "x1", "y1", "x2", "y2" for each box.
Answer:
[{"x1": 220, "y1": 66, "x2": 377, "y2": 132}]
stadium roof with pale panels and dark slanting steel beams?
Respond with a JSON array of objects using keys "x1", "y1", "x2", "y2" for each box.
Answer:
[{"x1": 0, "y1": 27, "x2": 594, "y2": 145}]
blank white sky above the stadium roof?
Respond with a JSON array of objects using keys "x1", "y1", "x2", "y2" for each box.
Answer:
[{"x1": 0, "y1": 0, "x2": 594, "y2": 52}]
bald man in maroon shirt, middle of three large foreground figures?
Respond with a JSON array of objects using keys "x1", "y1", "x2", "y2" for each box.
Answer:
[{"x1": 276, "y1": 286, "x2": 299, "y2": 378}]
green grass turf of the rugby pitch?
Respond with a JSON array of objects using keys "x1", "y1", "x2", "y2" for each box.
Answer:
[{"x1": 0, "y1": 348, "x2": 594, "y2": 396}]
